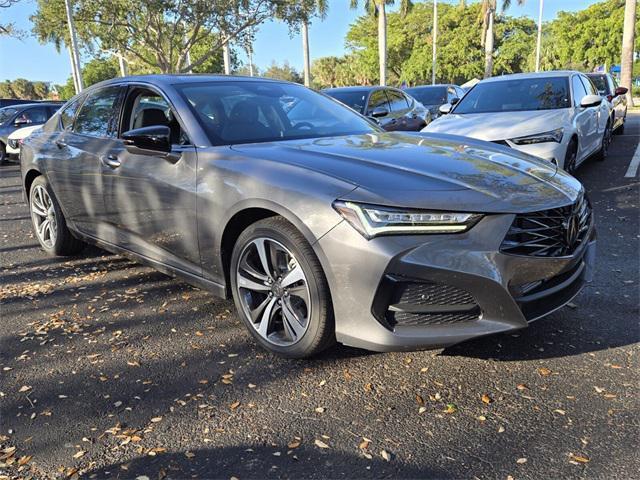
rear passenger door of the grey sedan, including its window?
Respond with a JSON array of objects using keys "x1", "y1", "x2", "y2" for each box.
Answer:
[{"x1": 48, "y1": 85, "x2": 123, "y2": 238}]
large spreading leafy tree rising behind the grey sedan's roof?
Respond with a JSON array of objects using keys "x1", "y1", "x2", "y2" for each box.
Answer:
[{"x1": 33, "y1": 0, "x2": 281, "y2": 73}]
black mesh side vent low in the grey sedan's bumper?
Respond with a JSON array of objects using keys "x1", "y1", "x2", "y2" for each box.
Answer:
[{"x1": 374, "y1": 277, "x2": 480, "y2": 329}]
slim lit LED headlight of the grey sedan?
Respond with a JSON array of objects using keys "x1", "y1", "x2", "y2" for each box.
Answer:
[{"x1": 333, "y1": 201, "x2": 482, "y2": 239}]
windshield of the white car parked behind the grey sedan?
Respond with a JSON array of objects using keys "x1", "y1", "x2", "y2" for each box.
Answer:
[{"x1": 453, "y1": 77, "x2": 571, "y2": 114}]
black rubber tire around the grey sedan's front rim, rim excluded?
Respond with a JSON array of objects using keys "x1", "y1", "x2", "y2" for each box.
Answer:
[{"x1": 230, "y1": 216, "x2": 335, "y2": 358}]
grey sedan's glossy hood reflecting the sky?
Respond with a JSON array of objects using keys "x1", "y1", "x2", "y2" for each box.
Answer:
[{"x1": 232, "y1": 132, "x2": 582, "y2": 213}]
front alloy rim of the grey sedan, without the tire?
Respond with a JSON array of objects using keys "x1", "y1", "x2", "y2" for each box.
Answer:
[{"x1": 236, "y1": 237, "x2": 311, "y2": 346}]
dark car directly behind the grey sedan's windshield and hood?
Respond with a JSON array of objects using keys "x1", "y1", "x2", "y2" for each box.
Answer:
[{"x1": 322, "y1": 87, "x2": 431, "y2": 132}]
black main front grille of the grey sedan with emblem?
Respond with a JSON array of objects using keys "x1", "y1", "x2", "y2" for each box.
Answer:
[{"x1": 500, "y1": 194, "x2": 592, "y2": 257}]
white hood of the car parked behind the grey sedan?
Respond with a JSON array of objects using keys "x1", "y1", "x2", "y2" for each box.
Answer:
[{"x1": 423, "y1": 108, "x2": 571, "y2": 141}]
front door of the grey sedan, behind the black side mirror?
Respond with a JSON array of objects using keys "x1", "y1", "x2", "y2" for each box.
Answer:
[{"x1": 101, "y1": 84, "x2": 202, "y2": 275}]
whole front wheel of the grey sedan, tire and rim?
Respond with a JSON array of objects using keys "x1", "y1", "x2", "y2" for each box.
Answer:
[{"x1": 230, "y1": 216, "x2": 335, "y2": 358}]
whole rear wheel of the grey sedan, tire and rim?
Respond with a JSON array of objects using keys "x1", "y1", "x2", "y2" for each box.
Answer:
[{"x1": 29, "y1": 176, "x2": 85, "y2": 255}]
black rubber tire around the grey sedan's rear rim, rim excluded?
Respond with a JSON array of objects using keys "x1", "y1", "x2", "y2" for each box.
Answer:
[{"x1": 29, "y1": 175, "x2": 85, "y2": 256}]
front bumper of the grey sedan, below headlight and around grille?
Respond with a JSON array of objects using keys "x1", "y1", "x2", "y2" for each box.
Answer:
[{"x1": 316, "y1": 214, "x2": 596, "y2": 351}]
